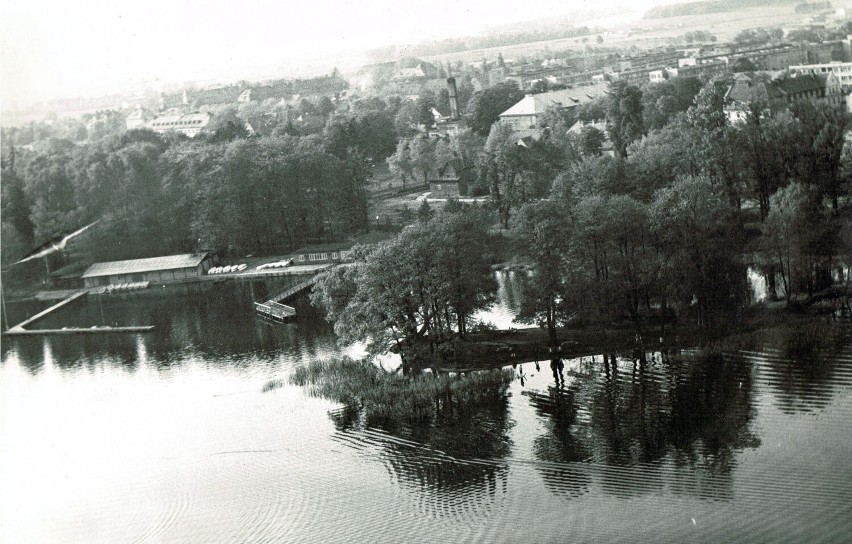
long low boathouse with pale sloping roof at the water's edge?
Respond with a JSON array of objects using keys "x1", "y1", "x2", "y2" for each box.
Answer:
[{"x1": 82, "y1": 253, "x2": 212, "y2": 288}]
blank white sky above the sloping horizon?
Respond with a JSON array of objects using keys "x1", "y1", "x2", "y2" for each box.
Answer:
[{"x1": 0, "y1": 0, "x2": 671, "y2": 107}]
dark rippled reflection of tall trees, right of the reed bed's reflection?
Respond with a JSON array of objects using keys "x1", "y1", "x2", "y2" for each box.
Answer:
[{"x1": 525, "y1": 354, "x2": 760, "y2": 498}]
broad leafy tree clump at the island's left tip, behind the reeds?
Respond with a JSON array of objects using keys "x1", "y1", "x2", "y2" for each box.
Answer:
[{"x1": 311, "y1": 208, "x2": 496, "y2": 364}]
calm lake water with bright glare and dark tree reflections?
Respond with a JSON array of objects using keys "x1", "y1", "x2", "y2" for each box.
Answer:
[{"x1": 0, "y1": 276, "x2": 852, "y2": 543}]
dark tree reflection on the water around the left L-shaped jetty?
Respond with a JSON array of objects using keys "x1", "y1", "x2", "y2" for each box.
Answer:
[{"x1": 3, "y1": 283, "x2": 333, "y2": 373}]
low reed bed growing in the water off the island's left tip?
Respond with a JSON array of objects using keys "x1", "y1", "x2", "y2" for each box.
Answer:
[{"x1": 290, "y1": 358, "x2": 513, "y2": 430}]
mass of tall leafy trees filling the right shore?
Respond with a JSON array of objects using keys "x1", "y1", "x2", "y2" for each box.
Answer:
[{"x1": 515, "y1": 82, "x2": 852, "y2": 336}]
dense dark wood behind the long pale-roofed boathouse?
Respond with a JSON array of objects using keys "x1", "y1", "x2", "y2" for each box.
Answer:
[{"x1": 2, "y1": 117, "x2": 376, "y2": 274}]
